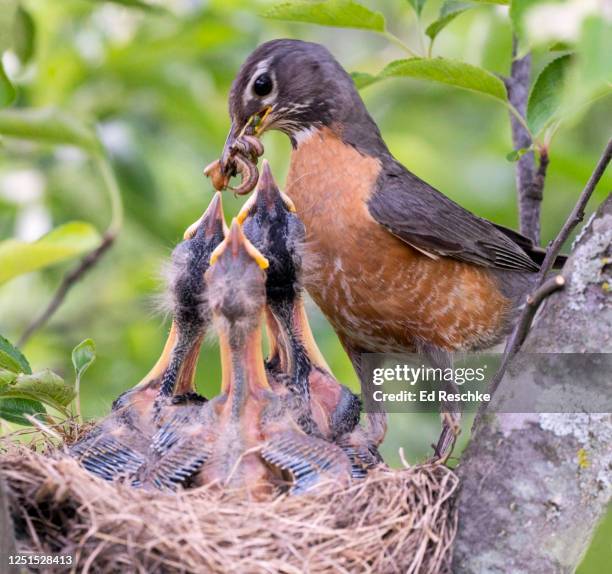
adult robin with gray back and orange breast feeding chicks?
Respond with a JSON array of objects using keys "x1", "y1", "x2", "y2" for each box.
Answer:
[{"x1": 215, "y1": 40, "x2": 564, "y2": 455}]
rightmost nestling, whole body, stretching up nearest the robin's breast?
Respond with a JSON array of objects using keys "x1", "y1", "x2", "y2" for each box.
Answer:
[{"x1": 238, "y1": 160, "x2": 381, "y2": 477}]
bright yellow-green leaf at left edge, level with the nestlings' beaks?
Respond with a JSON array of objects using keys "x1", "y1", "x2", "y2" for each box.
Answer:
[{"x1": 0, "y1": 221, "x2": 100, "y2": 285}]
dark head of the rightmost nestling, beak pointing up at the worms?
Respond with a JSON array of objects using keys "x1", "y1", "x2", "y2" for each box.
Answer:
[{"x1": 238, "y1": 160, "x2": 306, "y2": 301}]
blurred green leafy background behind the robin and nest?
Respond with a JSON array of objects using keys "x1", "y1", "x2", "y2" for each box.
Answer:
[{"x1": 0, "y1": 0, "x2": 612, "y2": 573}]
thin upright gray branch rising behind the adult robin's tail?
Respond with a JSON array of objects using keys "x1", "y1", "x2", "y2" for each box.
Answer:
[{"x1": 505, "y1": 37, "x2": 548, "y2": 245}]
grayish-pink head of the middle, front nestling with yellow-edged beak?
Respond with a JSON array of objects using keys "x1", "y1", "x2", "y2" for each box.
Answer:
[{"x1": 205, "y1": 219, "x2": 268, "y2": 331}]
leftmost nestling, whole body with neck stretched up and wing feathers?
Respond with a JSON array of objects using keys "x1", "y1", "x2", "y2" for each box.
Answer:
[{"x1": 69, "y1": 193, "x2": 224, "y2": 484}]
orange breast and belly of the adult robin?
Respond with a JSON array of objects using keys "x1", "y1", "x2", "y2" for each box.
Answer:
[{"x1": 285, "y1": 128, "x2": 509, "y2": 352}]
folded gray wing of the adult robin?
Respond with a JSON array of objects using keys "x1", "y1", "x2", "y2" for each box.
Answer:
[{"x1": 367, "y1": 166, "x2": 538, "y2": 271}]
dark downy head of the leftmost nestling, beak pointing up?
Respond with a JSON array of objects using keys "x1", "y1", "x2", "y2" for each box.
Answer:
[{"x1": 168, "y1": 192, "x2": 226, "y2": 326}]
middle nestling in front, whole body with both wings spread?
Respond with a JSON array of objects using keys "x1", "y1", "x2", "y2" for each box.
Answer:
[{"x1": 145, "y1": 221, "x2": 350, "y2": 498}]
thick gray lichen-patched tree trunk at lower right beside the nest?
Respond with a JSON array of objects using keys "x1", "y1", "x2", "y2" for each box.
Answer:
[{"x1": 453, "y1": 196, "x2": 612, "y2": 573}]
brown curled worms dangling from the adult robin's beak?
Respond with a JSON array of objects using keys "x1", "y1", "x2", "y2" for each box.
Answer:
[{"x1": 204, "y1": 135, "x2": 264, "y2": 195}]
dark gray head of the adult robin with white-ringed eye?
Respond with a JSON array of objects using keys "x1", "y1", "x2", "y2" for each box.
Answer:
[{"x1": 229, "y1": 40, "x2": 363, "y2": 147}]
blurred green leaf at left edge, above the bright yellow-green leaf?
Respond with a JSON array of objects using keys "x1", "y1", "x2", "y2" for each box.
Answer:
[{"x1": 0, "y1": 108, "x2": 102, "y2": 153}]
